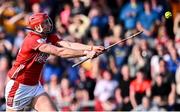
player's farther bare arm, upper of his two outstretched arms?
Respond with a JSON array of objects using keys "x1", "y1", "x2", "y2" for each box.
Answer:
[{"x1": 57, "y1": 40, "x2": 104, "y2": 52}]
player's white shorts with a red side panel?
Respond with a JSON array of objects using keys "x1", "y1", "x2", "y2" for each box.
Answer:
[{"x1": 5, "y1": 80, "x2": 45, "y2": 110}]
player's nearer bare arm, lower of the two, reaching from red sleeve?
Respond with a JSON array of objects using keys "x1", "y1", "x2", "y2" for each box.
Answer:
[{"x1": 38, "y1": 44, "x2": 95, "y2": 58}]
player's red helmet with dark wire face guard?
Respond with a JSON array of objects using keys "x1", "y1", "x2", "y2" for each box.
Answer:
[{"x1": 29, "y1": 13, "x2": 53, "y2": 34}]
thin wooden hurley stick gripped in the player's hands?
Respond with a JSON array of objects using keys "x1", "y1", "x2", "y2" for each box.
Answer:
[{"x1": 72, "y1": 31, "x2": 143, "y2": 67}]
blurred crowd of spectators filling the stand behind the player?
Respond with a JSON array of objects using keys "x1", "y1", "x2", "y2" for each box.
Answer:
[{"x1": 0, "y1": 0, "x2": 180, "y2": 111}]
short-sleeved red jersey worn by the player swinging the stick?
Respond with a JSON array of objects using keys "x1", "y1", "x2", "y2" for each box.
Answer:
[{"x1": 8, "y1": 32, "x2": 60, "y2": 85}]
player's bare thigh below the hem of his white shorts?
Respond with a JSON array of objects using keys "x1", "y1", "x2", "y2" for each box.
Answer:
[{"x1": 32, "y1": 92, "x2": 58, "y2": 111}]
